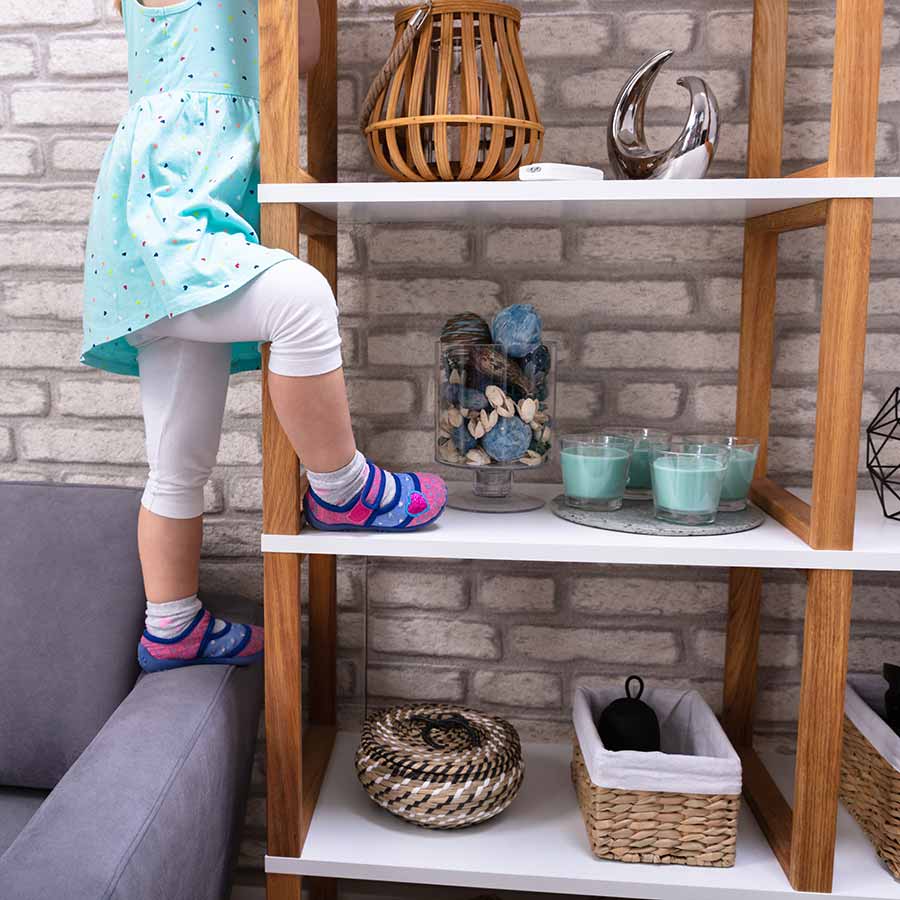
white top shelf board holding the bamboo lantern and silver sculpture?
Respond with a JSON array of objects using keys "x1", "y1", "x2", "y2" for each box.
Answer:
[{"x1": 259, "y1": 178, "x2": 900, "y2": 224}]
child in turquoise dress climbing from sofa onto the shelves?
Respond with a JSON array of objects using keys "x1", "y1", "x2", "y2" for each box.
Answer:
[{"x1": 82, "y1": 0, "x2": 447, "y2": 671}]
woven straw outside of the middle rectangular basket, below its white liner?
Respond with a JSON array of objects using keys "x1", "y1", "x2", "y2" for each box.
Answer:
[{"x1": 572, "y1": 737, "x2": 741, "y2": 868}]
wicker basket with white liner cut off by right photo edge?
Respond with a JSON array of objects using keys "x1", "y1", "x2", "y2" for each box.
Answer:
[{"x1": 841, "y1": 675, "x2": 900, "y2": 878}]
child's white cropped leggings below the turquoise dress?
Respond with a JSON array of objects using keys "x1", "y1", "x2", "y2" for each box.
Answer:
[{"x1": 128, "y1": 260, "x2": 341, "y2": 519}]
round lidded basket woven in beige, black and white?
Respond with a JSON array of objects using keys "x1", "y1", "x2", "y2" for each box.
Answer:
[{"x1": 356, "y1": 704, "x2": 525, "y2": 828}]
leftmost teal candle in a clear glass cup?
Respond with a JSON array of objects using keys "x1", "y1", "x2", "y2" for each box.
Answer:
[{"x1": 560, "y1": 434, "x2": 634, "y2": 512}]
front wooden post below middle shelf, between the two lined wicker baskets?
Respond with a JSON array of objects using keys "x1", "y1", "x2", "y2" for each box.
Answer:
[{"x1": 789, "y1": 571, "x2": 853, "y2": 893}]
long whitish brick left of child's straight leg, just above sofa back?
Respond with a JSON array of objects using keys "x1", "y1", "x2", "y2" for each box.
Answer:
[{"x1": 19, "y1": 423, "x2": 146, "y2": 464}]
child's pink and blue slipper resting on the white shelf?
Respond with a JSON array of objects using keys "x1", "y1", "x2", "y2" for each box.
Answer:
[{"x1": 305, "y1": 460, "x2": 447, "y2": 531}]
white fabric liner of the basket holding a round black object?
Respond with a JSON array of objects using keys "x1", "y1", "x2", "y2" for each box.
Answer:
[{"x1": 572, "y1": 685, "x2": 741, "y2": 795}]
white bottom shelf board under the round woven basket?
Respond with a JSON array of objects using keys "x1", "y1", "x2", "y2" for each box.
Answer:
[{"x1": 266, "y1": 733, "x2": 900, "y2": 900}]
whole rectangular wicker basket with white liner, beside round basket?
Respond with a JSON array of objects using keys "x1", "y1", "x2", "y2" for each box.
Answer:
[{"x1": 572, "y1": 688, "x2": 741, "y2": 867}]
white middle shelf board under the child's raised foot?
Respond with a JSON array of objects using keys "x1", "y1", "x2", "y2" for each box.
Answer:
[{"x1": 262, "y1": 484, "x2": 900, "y2": 572}]
